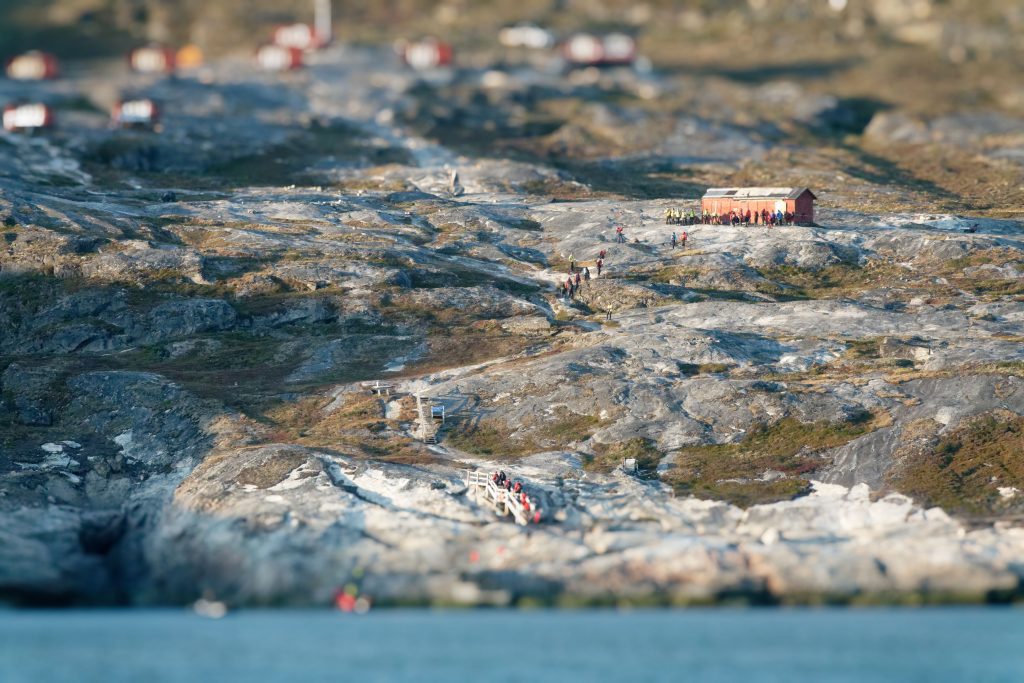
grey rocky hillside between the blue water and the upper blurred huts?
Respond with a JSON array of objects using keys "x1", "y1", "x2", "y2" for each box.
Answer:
[{"x1": 0, "y1": 13, "x2": 1024, "y2": 604}]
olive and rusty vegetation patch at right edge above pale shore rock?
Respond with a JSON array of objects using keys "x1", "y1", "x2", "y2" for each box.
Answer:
[{"x1": 889, "y1": 411, "x2": 1024, "y2": 517}]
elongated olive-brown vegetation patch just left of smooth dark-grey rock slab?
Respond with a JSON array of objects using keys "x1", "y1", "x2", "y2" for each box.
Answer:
[{"x1": 663, "y1": 411, "x2": 889, "y2": 507}]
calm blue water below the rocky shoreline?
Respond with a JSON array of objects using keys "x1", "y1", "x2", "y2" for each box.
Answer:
[{"x1": 0, "y1": 608, "x2": 1024, "y2": 683}]
